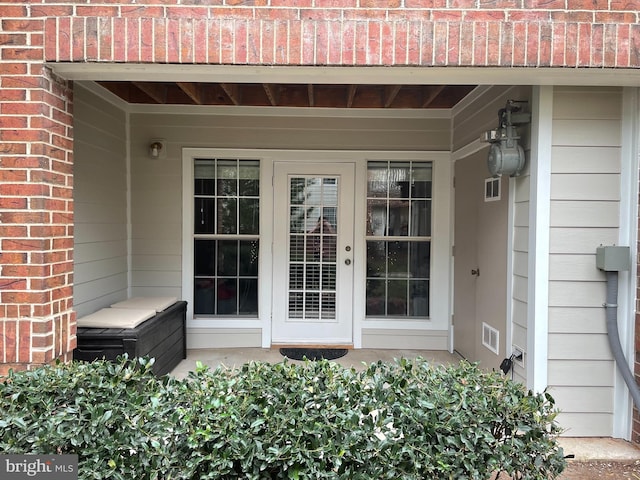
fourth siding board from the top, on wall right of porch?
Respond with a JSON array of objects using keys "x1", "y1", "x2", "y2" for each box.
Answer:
[{"x1": 551, "y1": 174, "x2": 620, "y2": 201}]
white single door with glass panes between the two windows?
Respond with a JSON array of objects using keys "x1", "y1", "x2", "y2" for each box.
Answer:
[{"x1": 271, "y1": 162, "x2": 354, "y2": 345}]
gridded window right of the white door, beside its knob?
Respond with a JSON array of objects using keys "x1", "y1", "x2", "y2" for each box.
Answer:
[{"x1": 366, "y1": 161, "x2": 432, "y2": 318}]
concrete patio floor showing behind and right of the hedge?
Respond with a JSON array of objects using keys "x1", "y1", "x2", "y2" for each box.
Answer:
[{"x1": 171, "y1": 348, "x2": 640, "y2": 462}]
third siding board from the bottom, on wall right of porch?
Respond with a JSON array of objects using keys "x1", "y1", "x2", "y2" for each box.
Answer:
[{"x1": 549, "y1": 360, "x2": 616, "y2": 387}]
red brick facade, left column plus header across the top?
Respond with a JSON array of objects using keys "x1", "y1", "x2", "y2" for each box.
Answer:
[{"x1": 0, "y1": 0, "x2": 640, "y2": 440}]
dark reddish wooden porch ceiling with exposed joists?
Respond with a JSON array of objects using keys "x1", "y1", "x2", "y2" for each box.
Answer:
[{"x1": 97, "y1": 81, "x2": 476, "y2": 109}]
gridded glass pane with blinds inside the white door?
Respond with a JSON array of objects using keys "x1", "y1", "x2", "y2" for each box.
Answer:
[{"x1": 288, "y1": 177, "x2": 338, "y2": 320}]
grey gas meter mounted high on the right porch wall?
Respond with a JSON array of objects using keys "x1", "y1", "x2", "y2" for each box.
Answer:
[{"x1": 481, "y1": 100, "x2": 531, "y2": 177}]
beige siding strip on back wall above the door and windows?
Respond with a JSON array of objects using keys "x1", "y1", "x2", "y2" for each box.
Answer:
[{"x1": 131, "y1": 113, "x2": 450, "y2": 151}]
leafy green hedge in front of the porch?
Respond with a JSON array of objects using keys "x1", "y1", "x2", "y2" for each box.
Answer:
[{"x1": 0, "y1": 359, "x2": 565, "y2": 480}]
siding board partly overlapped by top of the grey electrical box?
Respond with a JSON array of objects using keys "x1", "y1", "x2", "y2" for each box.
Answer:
[{"x1": 549, "y1": 228, "x2": 618, "y2": 254}]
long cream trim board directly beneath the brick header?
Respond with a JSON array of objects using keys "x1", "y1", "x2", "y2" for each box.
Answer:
[{"x1": 47, "y1": 62, "x2": 640, "y2": 87}]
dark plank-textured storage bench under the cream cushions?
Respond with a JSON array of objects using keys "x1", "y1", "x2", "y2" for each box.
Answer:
[{"x1": 73, "y1": 301, "x2": 187, "y2": 375}]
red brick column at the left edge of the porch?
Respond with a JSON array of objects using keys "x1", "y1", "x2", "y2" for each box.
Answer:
[{"x1": 0, "y1": 4, "x2": 75, "y2": 375}]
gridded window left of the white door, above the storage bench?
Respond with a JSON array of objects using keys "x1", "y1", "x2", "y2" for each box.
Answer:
[{"x1": 193, "y1": 159, "x2": 260, "y2": 316}]
